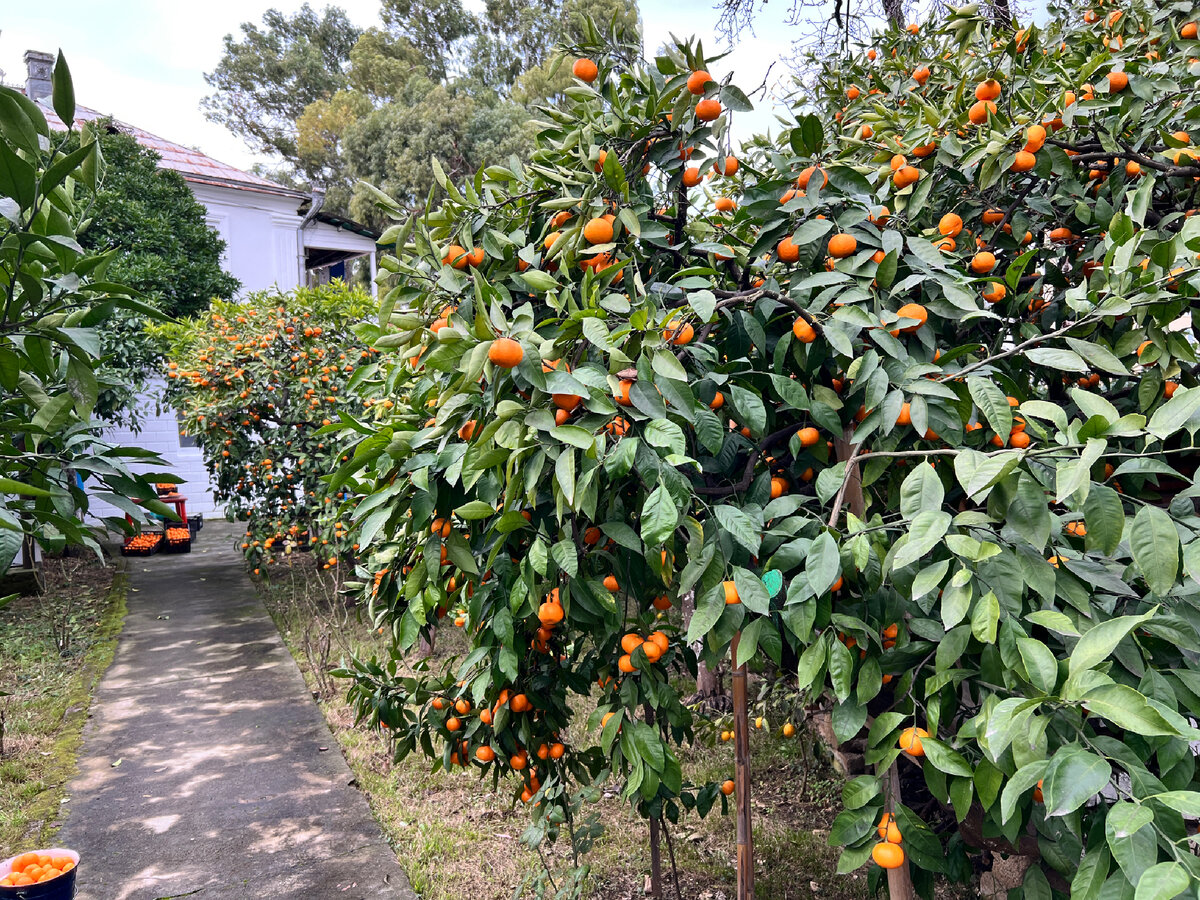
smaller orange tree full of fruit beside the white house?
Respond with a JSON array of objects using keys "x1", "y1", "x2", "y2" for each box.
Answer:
[{"x1": 158, "y1": 284, "x2": 376, "y2": 566}]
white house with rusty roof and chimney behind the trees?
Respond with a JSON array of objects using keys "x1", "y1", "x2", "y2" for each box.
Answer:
[{"x1": 24, "y1": 50, "x2": 378, "y2": 515}]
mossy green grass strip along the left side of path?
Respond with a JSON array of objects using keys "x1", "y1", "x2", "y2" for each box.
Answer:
[{"x1": 0, "y1": 557, "x2": 125, "y2": 858}]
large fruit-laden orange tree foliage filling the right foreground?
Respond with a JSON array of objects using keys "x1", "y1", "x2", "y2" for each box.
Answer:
[{"x1": 338, "y1": 4, "x2": 1200, "y2": 898}]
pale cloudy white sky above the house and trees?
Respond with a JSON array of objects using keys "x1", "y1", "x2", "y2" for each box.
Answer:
[{"x1": 0, "y1": 0, "x2": 854, "y2": 175}]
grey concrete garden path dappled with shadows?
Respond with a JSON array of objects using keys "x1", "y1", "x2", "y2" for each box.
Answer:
[{"x1": 60, "y1": 522, "x2": 416, "y2": 900}]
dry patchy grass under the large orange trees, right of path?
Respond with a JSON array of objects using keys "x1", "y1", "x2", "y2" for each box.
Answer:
[{"x1": 259, "y1": 558, "x2": 868, "y2": 900}]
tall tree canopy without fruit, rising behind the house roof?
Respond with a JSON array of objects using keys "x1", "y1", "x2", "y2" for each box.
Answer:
[{"x1": 205, "y1": 0, "x2": 641, "y2": 222}]
